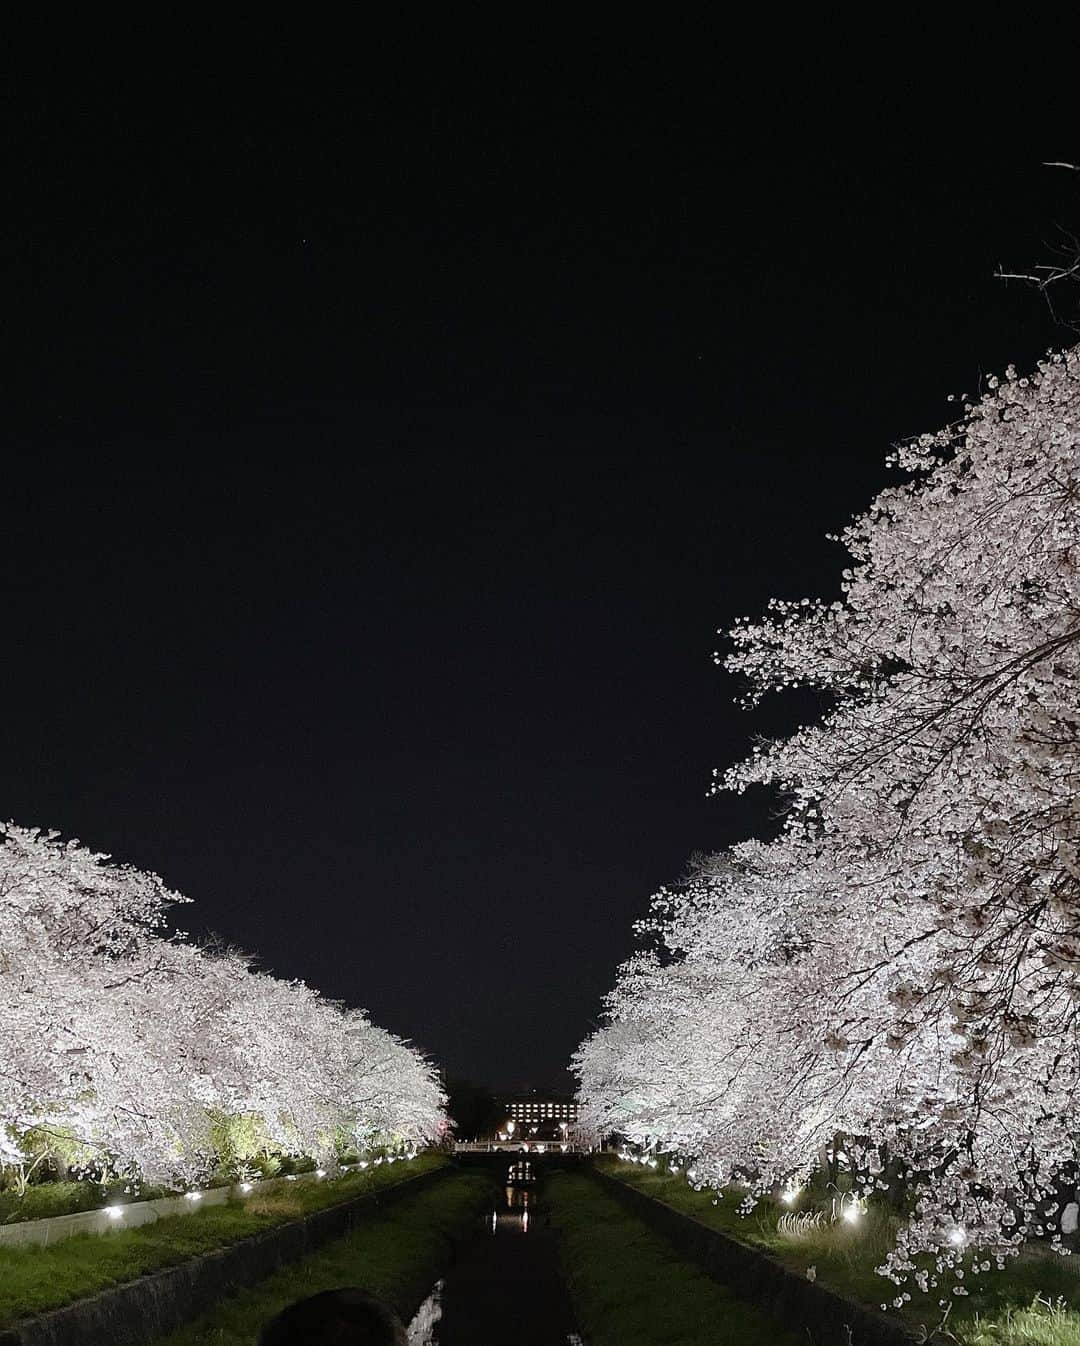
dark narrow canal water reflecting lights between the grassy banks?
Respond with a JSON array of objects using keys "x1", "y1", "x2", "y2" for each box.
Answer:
[{"x1": 409, "y1": 1164, "x2": 580, "y2": 1346}]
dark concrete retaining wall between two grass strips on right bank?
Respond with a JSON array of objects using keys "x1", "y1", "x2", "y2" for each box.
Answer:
[{"x1": 589, "y1": 1168, "x2": 940, "y2": 1346}]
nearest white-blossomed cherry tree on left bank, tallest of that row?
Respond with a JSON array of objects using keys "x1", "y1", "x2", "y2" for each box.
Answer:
[{"x1": 0, "y1": 825, "x2": 206, "y2": 1170}]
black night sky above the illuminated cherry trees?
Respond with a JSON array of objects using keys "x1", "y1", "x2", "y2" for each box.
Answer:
[{"x1": 0, "y1": 43, "x2": 1080, "y2": 1085}]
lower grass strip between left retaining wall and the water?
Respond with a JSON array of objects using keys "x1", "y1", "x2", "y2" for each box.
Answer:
[{"x1": 158, "y1": 1171, "x2": 492, "y2": 1346}]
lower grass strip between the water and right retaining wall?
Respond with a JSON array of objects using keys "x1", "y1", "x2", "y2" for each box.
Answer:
[{"x1": 545, "y1": 1174, "x2": 803, "y2": 1346}]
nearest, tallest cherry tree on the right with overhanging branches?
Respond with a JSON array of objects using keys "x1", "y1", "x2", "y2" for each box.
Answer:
[{"x1": 727, "y1": 351, "x2": 1080, "y2": 1261}]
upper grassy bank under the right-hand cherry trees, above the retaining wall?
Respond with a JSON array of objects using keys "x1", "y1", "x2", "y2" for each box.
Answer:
[{"x1": 599, "y1": 1158, "x2": 1080, "y2": 1346}]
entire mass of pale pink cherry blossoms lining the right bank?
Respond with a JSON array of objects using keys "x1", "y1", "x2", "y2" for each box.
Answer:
[{"x1": 575, "y1": 349, "x2": 1080, "y2": 1294}]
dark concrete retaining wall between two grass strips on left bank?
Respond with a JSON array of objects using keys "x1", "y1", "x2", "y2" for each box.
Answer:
[{"x1": 0, "y1": 1167, "x2": 452, "y2": 1346}]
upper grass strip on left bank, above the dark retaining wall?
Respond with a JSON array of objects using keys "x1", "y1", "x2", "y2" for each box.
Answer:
[{"x1": 0, "y1": 1155, "x2": 446, "y2": 1324}]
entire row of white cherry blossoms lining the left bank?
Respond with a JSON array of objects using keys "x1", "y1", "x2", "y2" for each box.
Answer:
[{"x1": 0, "y1": 824, "x2": 444, "y2": 1182}]
